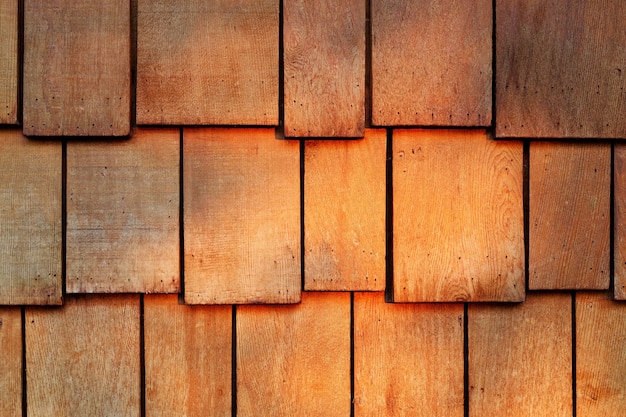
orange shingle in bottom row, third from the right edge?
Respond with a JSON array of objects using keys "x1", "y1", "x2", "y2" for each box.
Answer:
[{"x1": 354, "y1": 293, "x2": 463, "y2": 417}]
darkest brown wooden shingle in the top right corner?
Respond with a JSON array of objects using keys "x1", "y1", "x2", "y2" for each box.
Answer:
[{"x1": 496, "y1": 0, "x2": 626, "y2": 139}]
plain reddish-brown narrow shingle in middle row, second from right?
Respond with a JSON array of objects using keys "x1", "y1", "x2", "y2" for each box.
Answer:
[{"x1": 528, "y1": 142, "x2": 611, "y2": 289}]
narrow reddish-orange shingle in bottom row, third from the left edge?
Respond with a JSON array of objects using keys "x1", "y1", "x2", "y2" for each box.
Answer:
[{"x1": 144, "y1": 295, "x2": 232, "y2": 417}]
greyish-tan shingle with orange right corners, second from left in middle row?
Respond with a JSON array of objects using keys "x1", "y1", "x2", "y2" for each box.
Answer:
[{"x1": 66, "y1": 129, "x2": 180, "y2": 293}]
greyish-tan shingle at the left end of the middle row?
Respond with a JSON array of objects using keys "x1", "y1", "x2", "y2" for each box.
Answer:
[{"x1": 0, "y1": 130, "x2": 62, "y2": 304}]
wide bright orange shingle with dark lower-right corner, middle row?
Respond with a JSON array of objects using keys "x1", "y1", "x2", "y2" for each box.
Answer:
[{"x1": 392, "y1": 130, "x2": 524, "y2": 302}]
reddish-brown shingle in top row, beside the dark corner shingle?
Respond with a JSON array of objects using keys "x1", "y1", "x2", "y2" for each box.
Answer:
[{"x1": 371, "y1": 0, "x2": 492, "y2": 126}]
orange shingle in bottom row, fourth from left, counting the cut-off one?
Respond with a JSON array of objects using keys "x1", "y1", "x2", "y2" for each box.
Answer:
[{"x1": 237, "y1": 293, "x2": 350, "y2": 417}]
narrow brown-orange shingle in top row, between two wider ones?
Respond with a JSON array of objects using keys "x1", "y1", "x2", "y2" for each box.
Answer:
[{"x1": 283, "y1": 0, "x2": 366, "y2": 137}]
